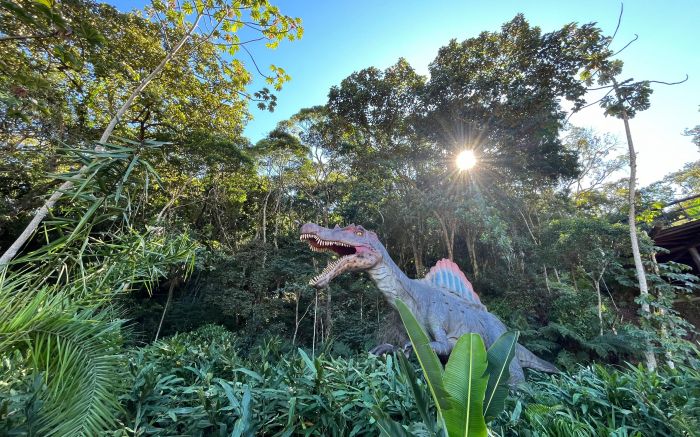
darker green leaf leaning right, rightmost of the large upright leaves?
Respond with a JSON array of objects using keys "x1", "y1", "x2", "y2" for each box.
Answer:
[{"x1": 484, "y1": 331, "x2": 520, "y2": 422}]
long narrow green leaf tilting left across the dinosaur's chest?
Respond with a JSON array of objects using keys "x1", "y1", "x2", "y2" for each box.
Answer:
[{"x1": 396, "y1": 299, "x2": 451, "y2": 410}]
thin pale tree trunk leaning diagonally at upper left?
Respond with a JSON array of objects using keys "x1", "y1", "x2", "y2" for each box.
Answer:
[{"x1": 0, "y1": 15, "x2": 202, "y2": 267}]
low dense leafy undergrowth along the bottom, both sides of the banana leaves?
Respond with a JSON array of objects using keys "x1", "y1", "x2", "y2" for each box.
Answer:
[{"x1": 3, "y1": 325, "x2": 700, "y2": 436}]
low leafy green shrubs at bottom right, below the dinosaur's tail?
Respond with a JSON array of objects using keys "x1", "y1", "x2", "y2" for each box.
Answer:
[{"x1": 494, "y1": 364, "x2": 700, "y2": 436}]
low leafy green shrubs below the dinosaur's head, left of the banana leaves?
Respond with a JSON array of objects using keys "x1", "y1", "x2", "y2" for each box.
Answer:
[{"x1": 121, "y1": 325, "x2": 422, "y2": 436}]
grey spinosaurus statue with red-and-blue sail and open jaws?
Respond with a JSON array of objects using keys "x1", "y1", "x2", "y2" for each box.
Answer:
[{"x1": 300, "y1": 223, "x2": 558, "y2": 384}]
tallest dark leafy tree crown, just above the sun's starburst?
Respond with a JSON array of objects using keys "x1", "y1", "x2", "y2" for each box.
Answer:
[{"x1": 423, "y1": 15, "x2": 600, "y2": 185}]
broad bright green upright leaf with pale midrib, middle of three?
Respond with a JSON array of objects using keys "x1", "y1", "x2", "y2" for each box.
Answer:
[{"x1": 443, "y1": 334, "x2": 488, "y2": 437}]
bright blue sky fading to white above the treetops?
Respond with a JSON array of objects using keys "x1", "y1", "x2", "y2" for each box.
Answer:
[{"x1": 111, "y1": 0, "x2": 700, "y2": 184}]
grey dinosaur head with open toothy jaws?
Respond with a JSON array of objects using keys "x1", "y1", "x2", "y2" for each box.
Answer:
[{"x1": 300, "y1": 223, "x2": 383, "y2": 288}]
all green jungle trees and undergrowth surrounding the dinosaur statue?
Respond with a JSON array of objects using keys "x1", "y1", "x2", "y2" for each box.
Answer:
[{"x1": 0, "y1": 0, "x2": 700, "y2": 436}]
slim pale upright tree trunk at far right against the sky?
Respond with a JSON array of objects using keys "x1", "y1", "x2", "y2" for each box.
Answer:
[{"x1": 613, "y1": 79, "x2": 656, "y2": 370}]
